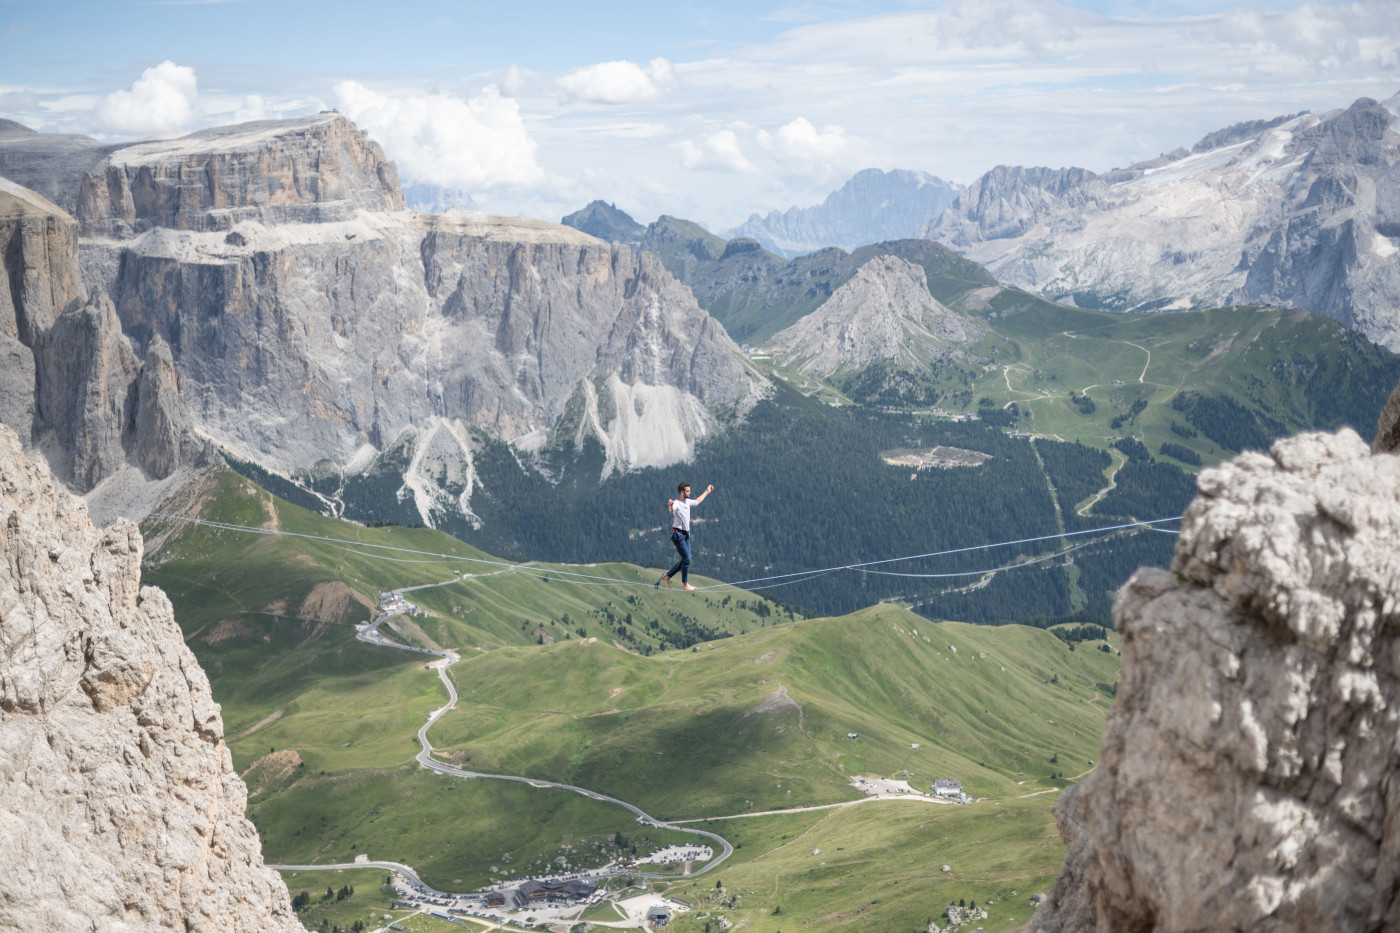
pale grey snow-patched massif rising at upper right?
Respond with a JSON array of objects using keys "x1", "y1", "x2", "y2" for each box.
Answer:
[{"x1": 920, "y1": 95, "x2": 1400, "y2": 349}]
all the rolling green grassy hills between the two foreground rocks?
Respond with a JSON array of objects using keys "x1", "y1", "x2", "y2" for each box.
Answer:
[{"x1": 146, "y1": 474, "x2": 1117, "y2": 929}]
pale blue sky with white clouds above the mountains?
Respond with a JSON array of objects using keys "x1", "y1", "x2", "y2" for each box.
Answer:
[{"x1": 0, "y1": 0, "x2": 1400, "y2": 231}]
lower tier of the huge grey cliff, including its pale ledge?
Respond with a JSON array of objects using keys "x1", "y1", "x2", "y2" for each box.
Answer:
[{"x1": 88, "y1": 212, "x2": 756, "y2": 487}]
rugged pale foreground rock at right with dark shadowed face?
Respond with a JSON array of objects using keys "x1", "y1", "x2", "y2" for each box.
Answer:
[{"x1": 1028, "y1": 430, "x2": 1400, "y2": 933}]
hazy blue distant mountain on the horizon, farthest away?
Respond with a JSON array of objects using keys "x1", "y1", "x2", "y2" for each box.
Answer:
[{"x1": 728, "y1": 168, "x2": 960, "y2": 259}]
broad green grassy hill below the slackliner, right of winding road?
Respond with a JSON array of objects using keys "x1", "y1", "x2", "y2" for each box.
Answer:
[{"x1": 434, "y1": 605, "x2": 1117, "y2": 820}]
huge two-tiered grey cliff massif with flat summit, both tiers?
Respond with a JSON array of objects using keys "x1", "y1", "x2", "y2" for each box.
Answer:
[{"x1": 0, "y1": 113, "x2": 763, "y2": 524}]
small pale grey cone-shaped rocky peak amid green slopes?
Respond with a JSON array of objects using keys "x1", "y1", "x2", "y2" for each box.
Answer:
[{"x1": 766, "y1": 256, "x2": 986, "y2": 378}]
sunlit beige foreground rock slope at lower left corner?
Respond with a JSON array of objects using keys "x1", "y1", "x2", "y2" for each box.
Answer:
[{"x1": 0, "y1": 426, "x2": 302, "y2": 933}]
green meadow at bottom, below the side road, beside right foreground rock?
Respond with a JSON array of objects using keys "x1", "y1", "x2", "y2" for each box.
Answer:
[{"x1": 669, "y1": 794, "x2": 1064, "y2": 933}]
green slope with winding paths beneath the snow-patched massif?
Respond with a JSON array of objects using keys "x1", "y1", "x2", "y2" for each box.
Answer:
[{"x1": 772, "y1": 279, "x2": 1400, "y2": 468}]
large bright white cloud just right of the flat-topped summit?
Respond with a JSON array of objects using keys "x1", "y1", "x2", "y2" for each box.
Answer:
[{"x1": 335, "y1": 81, "x2": 543, "y2": 192}]
